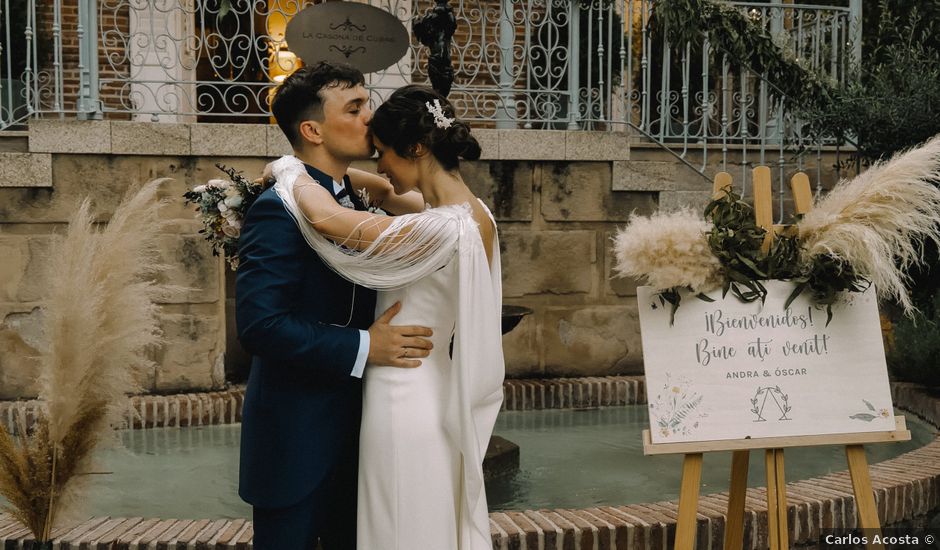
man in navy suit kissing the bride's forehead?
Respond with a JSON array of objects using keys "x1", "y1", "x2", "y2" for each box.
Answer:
[{"x1": 235, "y1": 63, "x2": 431, "y2": 550}]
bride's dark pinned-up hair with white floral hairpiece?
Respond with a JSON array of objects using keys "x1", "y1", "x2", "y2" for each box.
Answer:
[{"x1": 369, "y1": 84, "x2": 481, "y2": 170}]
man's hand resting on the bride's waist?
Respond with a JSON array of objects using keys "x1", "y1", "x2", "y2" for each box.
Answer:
[{"x1": 367, "y1": 302, "x2": 433, "y2": 368}]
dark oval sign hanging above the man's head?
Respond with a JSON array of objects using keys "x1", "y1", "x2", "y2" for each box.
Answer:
[{"x1": 284, "y1": 2, "x2": 409, "y2": 73}]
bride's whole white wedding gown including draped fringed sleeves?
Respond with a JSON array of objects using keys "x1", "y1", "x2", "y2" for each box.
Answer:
[{"x1": 274, "y1": 157, "x2": 505, "y2": 550}]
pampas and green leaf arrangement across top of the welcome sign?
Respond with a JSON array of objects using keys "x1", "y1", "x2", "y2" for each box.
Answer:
[{"x1": 614, "y1": 136, "x2": 940, "y2": 324}]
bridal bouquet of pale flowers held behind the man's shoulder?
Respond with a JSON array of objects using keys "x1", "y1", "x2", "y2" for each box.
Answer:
[{"x1": 183, "y1": 164, "x2": 264, "y2": 271}]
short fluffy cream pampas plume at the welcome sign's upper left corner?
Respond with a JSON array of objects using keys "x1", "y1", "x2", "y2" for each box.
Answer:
[{"x1": 613, "y1": 209, "x2": 721, "y2": 292}]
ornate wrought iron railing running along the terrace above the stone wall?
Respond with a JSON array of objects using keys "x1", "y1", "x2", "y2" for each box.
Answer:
[{"x1": 0, "y1": 0, "x2": 861, "y2": 169}]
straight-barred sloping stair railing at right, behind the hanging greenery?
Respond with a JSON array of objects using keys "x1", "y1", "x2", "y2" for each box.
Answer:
[{"x1": 620, "y1": 0, "x2": 861, "y2": 183}]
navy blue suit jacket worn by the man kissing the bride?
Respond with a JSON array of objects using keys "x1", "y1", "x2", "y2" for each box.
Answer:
[{"x1": 235, "y1": 167, "x2": 375, "y2": 508}]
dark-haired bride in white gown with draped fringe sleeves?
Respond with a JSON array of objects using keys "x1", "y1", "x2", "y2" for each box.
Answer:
[{"x1": 272, "y1": 86, "x2": 505, "y2": 550}]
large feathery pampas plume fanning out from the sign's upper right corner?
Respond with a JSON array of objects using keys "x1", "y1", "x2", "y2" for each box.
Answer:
[{"x1": 797, "y1": 136, "x2": 940, "y2": 315}]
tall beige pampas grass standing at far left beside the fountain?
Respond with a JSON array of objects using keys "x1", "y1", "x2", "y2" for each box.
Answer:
[{"x1": 0, "y1": 180, "x2": 171, "y2": 540}]
